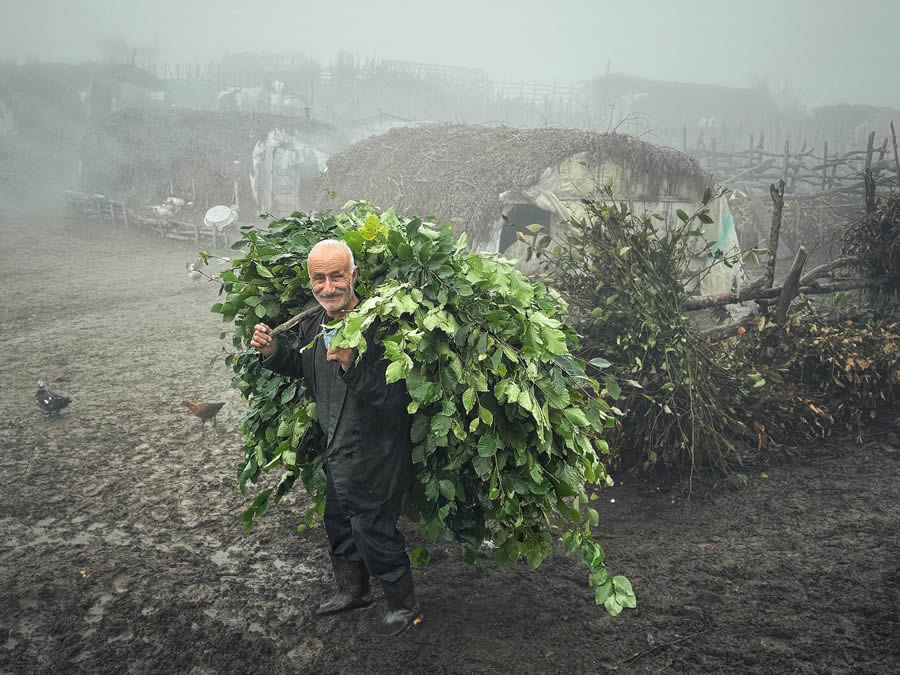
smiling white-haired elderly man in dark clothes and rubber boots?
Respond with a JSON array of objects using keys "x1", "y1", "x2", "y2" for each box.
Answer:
[{"x1": 250, "y1": 239, "x2": 421, "y2": 636}]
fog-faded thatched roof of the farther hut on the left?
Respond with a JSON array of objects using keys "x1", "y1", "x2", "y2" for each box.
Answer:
[{"x1": 81, "y1": 109, "x2": 346, "y2": 204}]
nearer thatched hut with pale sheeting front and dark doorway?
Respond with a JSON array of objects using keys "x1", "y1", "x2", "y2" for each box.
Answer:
[{"x1": 318, "y1": 125, "x2": 737, "y2": 292}]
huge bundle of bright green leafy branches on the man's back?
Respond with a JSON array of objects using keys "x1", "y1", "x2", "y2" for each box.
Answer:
[{"x1": 212, "y1": 202, "x2": 635, "y2": 614}]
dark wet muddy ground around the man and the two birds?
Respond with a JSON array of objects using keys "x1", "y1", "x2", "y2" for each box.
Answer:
[{"x1": 0, "y1": 219, "x2": 900, "y2": 674}]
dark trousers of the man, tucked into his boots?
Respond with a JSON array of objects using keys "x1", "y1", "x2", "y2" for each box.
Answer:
[{"x1": 323, "y1": 473, "x2": 409, "y2": 583}]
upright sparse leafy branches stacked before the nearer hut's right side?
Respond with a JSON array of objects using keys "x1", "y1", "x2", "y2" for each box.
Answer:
[{"x1": 531, "y1": 188, "x2": 744, "y2": 473}]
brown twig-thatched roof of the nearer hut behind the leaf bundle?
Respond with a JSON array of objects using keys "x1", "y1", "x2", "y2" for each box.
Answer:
[{"x1": 318, "y1": 124, "x2": 712, "y2": 240}]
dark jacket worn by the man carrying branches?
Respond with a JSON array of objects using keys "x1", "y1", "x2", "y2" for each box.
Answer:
[{"x1": 262, "y1": 309, "x2": 412, "y2": 515}]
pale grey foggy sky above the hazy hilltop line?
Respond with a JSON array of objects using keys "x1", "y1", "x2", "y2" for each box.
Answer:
[{"x1": 0, "y1": 0, "x2": 900, "y2": 107}]
